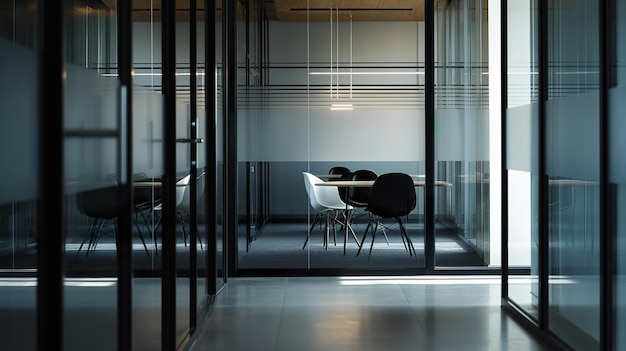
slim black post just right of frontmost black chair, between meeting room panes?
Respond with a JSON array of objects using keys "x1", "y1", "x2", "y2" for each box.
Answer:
[{"x1": 424, "y1": 1, "x2": 435, "y2": 272}]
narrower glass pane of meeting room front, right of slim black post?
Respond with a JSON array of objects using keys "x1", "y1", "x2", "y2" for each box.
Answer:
[{"x1": 435, "y1": 0, "x2": 492, "y2": 268}]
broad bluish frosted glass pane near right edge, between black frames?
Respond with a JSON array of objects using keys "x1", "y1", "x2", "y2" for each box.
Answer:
[{"x1": 545, "y1": 0, "x2": 602, "y2": 350}]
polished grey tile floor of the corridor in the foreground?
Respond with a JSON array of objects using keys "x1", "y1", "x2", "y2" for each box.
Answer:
[{"x1": 190, "y1": 276, "x2": 550, "y2": 351}]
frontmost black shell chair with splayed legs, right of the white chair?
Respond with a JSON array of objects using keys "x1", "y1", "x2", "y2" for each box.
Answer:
[{"x1": 357, "y1": 173, "x2": 417, "y2": 256}]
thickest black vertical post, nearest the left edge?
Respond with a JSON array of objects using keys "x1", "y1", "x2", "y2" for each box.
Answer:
[{"x1": 37, "y1": 0, "x2": 65, "y2": 351}]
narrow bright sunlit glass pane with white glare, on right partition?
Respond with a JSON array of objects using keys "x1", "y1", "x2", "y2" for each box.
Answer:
[{"x1": 505, "y1": 0, "x2": 540, "y2": 320}]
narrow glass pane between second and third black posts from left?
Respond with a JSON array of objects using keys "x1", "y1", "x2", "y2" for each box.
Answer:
[{"x1": 132, "y1": 3, "x2": 164, "y2": 348}]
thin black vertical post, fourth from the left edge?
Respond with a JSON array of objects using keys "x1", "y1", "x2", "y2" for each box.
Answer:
[{"x1": 189, "y1": 0, "x2": 197, "y2": 330}]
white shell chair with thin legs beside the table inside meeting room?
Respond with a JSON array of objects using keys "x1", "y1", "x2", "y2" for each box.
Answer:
[{"x1": 302, "y1": 172, "x2": 359, "y2": 254}]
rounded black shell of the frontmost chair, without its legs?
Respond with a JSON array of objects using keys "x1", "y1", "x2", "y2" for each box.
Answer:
[{"x1": 367, "y1": 173, "x2": 417, "y2": 218}]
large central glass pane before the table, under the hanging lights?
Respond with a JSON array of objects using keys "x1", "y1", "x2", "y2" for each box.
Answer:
[{"x1": 237, "y1": 1, "x2": 425, "y2": 272}]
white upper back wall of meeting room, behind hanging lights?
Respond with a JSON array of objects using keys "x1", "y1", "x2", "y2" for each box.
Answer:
[{"x1": 234, "y1": 22, "x2": 489, "y2": 161}]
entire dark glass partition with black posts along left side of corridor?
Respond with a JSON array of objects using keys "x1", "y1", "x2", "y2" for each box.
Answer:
[{"x1": 0, "y1": 0, "x2": 217, "y2": 350}]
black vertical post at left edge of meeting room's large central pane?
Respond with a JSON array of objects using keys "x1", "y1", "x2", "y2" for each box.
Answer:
[{"x1": 222, "y1": 1, "x2": 238, "y2": 277}]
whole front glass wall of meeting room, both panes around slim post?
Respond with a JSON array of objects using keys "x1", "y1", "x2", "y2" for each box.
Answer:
[{"x1": 230, "y1": 1, "x2": 500, "y2": 274}]
